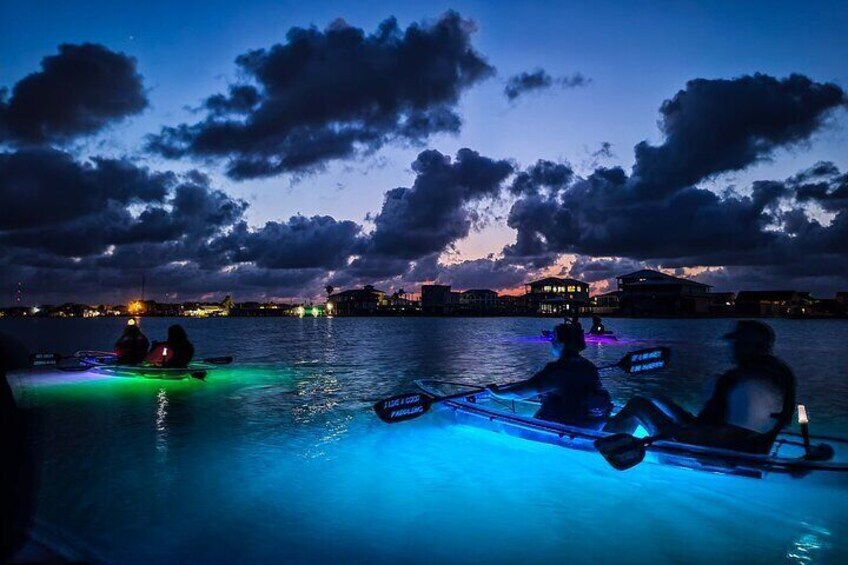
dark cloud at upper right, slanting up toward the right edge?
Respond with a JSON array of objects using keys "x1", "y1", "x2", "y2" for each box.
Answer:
[{"x1": 633, "y1": 74, "x2": 846, "y2": 198}]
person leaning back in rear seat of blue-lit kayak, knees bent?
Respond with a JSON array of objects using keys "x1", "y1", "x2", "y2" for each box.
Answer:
[{"x1": 604, "y1": 320, "x2": 795, "y2": 453}]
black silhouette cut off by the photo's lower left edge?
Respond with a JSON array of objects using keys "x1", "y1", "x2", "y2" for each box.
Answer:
[{"x1": 0, "y1": 333, "x2": 36, "y2": 562}]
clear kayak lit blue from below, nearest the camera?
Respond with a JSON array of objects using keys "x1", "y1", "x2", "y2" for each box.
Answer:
[{"x1": 416, "y1": 380, "x2": 848, "y2": 480}]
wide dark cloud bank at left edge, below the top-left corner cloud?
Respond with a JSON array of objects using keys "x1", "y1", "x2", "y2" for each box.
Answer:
[{"x1": 0, "y1": 149, "x2": 247, "y2": 259}]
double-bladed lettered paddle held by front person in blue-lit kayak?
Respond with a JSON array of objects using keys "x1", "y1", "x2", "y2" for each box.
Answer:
[{"x1": 373, "y1": 347, "x2": 671, "y2": 424}]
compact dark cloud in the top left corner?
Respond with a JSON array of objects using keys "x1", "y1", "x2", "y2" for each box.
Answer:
[{"x1": 0, "y1": 43, "x2": 147, "y2": 144}]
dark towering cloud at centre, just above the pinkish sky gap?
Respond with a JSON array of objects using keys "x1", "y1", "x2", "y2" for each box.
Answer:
[{"x1": 369, "y1": 149, "x2": 513, "y2": 260}]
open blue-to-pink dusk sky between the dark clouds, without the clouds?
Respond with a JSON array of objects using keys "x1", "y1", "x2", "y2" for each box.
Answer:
[{"x1": 0, "y1": 1, "x2": 848, "y2": 302}]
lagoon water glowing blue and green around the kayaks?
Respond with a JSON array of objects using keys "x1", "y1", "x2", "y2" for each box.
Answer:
[{"x1": 0, "y1": 318, "x2": 848, "y2": 563}]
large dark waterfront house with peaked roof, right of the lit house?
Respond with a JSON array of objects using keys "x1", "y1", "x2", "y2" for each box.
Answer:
[{"x1": 616, "y1": 269, "x2": 710, "y2": 316}]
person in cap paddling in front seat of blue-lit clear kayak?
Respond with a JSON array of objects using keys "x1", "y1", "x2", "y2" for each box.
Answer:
[{"x1": 489, "y1": 323, "x2": 612, "y2": 427}]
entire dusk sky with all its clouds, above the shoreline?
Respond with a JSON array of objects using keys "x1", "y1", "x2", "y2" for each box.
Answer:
[{"x1": 0, "y1": 0, "x2": 848, "y2": 305}]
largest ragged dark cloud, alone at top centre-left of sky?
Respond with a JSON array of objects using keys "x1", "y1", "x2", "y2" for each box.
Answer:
[{"x1": 149, "y1": 12, "x2": 494, "y2": 179}]
